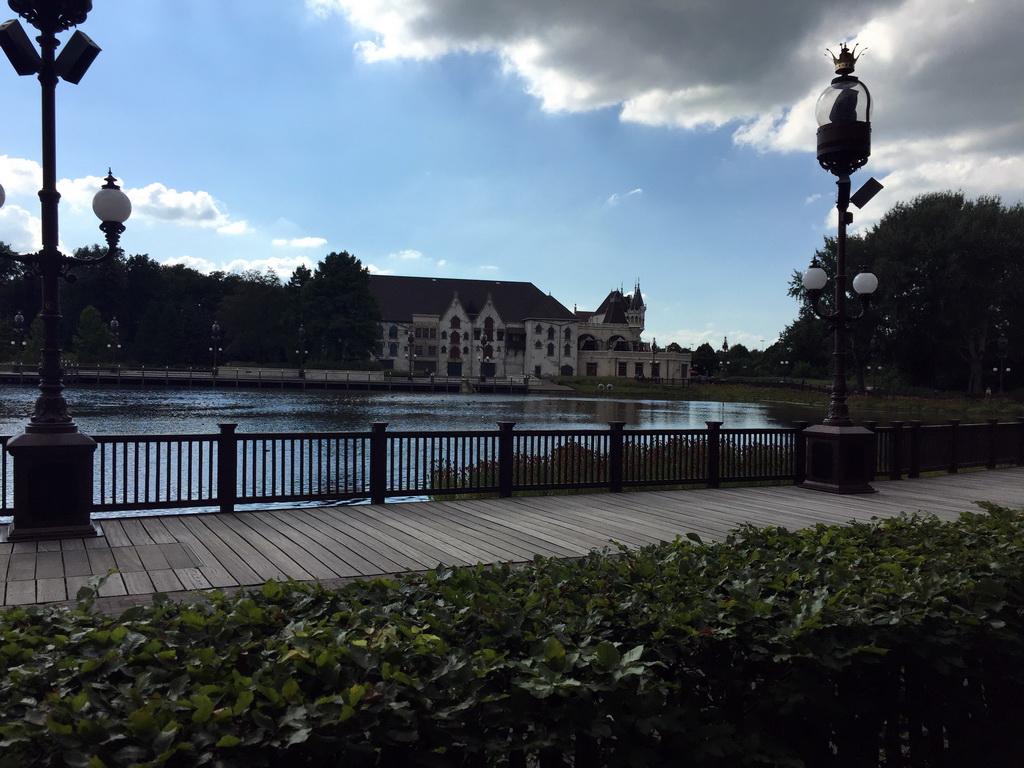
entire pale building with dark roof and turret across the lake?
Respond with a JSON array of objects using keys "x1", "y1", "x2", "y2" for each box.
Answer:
[{"x1": 370, "y1": 274, "x2": 690, "y2": 381}]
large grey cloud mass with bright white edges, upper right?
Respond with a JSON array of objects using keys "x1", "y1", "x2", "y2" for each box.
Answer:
[{"x1": 306, "y1": 0, "x2": 1024, "y2": 204}]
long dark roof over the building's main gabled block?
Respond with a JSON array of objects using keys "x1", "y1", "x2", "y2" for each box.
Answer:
[{"x1": 370, "y1": 274, "x2": 575, "y2": 323}]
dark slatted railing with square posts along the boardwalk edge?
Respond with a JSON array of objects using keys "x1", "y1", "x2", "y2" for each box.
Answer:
[{"x1": 0, "y1": 419, "x2": 1024, "y2": 515}]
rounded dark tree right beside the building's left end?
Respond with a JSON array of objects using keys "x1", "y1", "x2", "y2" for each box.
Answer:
[{"x1": 303, "y1": 251, "x2": 380, "y2": 364}]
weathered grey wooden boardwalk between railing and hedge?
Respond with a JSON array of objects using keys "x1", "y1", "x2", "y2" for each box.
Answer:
[{"x1": 0, "y1": 467, "x2": 1024, "y2": 611}]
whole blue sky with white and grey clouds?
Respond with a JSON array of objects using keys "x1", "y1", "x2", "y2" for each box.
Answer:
[{"x1": 0, "y1": 0, "x2": 1024, "y2": 349}]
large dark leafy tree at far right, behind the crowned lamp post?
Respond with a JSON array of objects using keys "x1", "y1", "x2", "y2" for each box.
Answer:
[{"x1": 866, "y1": 191, "x2": 1024, "y2": 394}]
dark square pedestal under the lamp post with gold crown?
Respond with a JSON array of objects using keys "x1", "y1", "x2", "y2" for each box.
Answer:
[{"x1": 800, "y1": 424, "x2": 877, "y2": 494}]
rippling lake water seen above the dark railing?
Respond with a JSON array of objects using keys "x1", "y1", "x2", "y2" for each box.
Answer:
[{"x1": 0, "y1": 387, "x2": 824, "y2": 434}]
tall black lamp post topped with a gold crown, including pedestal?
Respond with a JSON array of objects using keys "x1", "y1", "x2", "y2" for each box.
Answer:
[{"x1": 803, "y1": 43, "x2": 882, "y2": 494}]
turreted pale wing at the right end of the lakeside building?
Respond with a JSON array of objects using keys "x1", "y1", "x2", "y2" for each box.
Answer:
[{"x1": 575, "y1": 283, "x2": 690, "y2": 380}]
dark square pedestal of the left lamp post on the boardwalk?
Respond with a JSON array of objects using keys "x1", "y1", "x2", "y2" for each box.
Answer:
[{"x1": 6, "y1": 431, "x2": 100, "y2": 541}]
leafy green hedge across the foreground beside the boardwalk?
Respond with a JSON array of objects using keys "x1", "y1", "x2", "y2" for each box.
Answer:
[{"x1": 0, "y1": 507, "x2": 1024, "y2": 768}]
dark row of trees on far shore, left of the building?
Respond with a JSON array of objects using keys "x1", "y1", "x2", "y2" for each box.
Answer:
[{"x1": 0, "y1": 244, "x2": 379, "y2": 368}]
